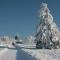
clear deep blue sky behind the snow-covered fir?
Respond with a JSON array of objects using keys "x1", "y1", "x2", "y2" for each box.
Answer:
[{"x1": 0, "y1": 0, "x2": 60, "y2": 37}]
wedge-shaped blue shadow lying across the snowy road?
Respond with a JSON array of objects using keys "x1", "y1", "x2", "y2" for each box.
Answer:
[{"x1": 16, "y1": 47, "x2": 37, "y2": 60}]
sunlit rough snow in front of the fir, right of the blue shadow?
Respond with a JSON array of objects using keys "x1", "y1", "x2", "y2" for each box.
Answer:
[{"x1": 22, "y1": 49, "x2": 60, "y2": 60}]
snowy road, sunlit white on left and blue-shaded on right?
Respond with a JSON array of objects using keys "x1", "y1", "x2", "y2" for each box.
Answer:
[{"x1": 0, "y1": 48, "x2": 36, "y2": 60}]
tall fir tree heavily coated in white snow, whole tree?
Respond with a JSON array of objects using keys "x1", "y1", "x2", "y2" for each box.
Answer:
[{"x1": 35, "y1": 3, "x2": 60, "y2": 49}]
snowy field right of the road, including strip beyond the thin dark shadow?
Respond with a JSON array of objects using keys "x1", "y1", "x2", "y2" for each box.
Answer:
[{"x1": 12, "y1": 44, "x2": 60, "y2": 60}]
